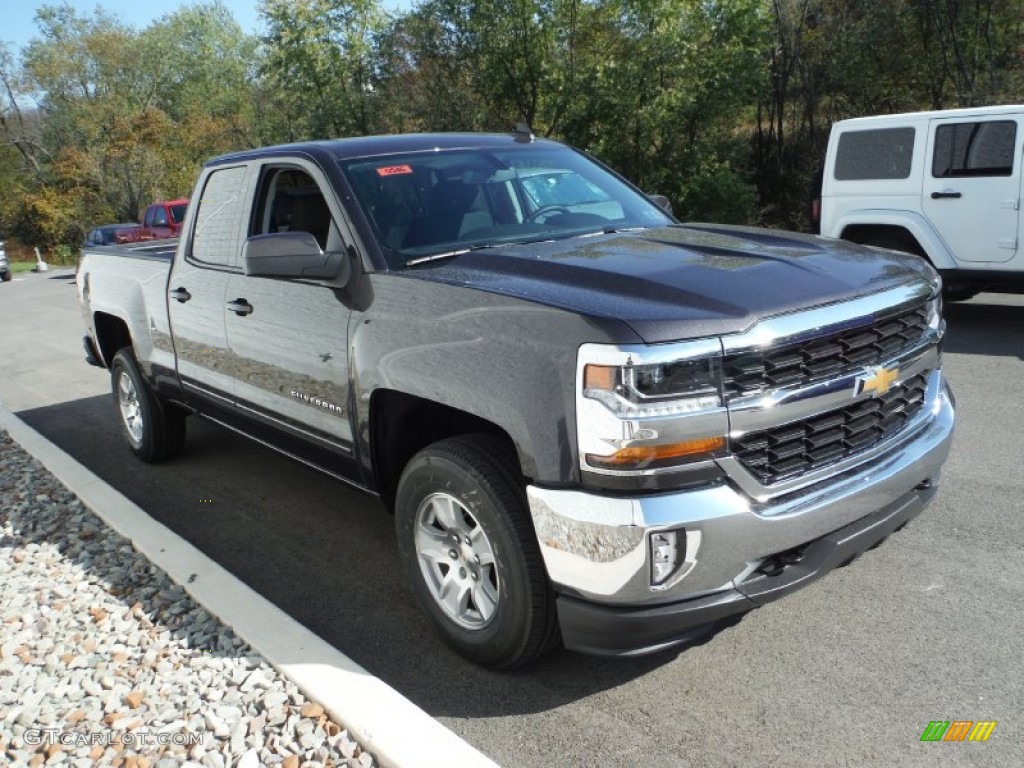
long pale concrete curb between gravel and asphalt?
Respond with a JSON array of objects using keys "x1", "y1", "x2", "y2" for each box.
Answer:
[{"x1": 0, "y1": 404, "x2": 498, "y2": 768}]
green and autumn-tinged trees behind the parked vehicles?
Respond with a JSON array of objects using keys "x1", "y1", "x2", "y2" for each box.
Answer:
[{"x1": 0, "y1": 0, "x2": 1024, "y2": 259}]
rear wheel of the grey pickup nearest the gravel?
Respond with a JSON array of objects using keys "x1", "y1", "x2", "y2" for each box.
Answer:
[{"x1": 111, "y1": 347, "x2": 186, "y2": 463}]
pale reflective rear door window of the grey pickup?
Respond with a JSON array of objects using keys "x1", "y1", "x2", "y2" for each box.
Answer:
[{"x1": 189, "y1": 166, "x2": 246, "y2": 266}]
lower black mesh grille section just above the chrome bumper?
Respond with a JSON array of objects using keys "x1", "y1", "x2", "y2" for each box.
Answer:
[{"x1": 730, "y1": 371, "x2": 931, "y2": 485}]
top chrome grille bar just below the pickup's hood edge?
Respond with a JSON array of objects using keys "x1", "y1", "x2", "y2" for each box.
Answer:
[{"x1": 722, "y1": 283, "x2": 932, "y2": 354}]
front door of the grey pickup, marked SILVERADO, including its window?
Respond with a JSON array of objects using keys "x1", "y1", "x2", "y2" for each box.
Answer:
[{"x1": 226, "y1": 159, "x2": 357, "y2": 479}]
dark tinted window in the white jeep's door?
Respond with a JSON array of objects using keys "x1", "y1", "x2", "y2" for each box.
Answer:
[{"x1": 932, "y1": 120, "x2": 1017, "y2": 178}]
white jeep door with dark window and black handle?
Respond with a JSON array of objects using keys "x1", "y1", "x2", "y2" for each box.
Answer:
[{"x1": 922, "y1": 115, "x2": 1024, "y2": 262}]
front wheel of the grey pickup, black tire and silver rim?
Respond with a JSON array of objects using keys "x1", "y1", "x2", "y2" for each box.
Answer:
[{"x1": 395, "y1": 435, "x2": 558, "y2": 670}]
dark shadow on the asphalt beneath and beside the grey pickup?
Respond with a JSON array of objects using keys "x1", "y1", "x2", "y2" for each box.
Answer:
[{"x1": 17, "y1": 396, "x2": 738, "y2": 718}]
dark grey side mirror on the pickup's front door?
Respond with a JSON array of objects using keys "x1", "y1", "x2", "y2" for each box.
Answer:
[{"x1": 242, "y1": 232, "x2": 351, "y2": 284}]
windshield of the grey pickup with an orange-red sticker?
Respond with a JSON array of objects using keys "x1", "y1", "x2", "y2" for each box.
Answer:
[{"x1": 341, "y1": 144, "x2": 672, "y2": 267}]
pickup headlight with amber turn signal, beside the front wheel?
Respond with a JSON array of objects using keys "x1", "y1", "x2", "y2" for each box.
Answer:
[{"x1": 577, "y1": 340, "x2": 728, "y2": 475}]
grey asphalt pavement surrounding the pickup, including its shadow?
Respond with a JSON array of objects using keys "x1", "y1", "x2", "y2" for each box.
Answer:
[{"x1": 0, "y1": 273, "x2": 1024, "y2": 768}]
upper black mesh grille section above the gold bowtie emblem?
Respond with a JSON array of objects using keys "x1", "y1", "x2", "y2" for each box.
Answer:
[{"x1": 723, "y1": 303, "x2": 928, "y2": 399}]
